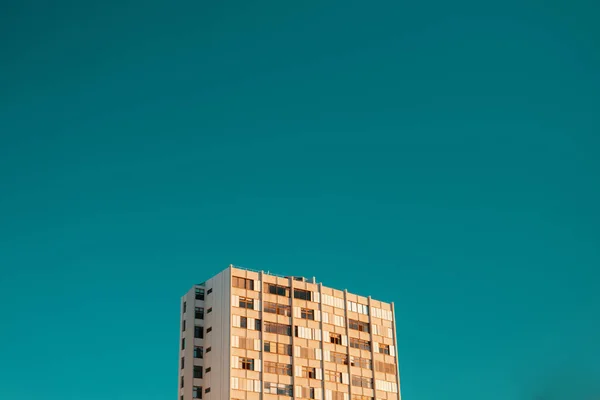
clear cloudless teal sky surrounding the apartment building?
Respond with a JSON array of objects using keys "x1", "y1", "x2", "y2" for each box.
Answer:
[{"x1": 0, "y1": 0, "x2": 600, "y2": 400}]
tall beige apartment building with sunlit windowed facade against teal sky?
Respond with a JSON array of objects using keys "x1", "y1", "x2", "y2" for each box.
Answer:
[{"x1": 178, "y1": 266, "x2": 400, "y2": 400}]
